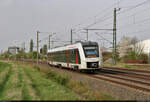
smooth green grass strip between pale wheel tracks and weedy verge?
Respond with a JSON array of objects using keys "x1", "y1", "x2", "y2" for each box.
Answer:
[{"x1": 24, "y1": 66, "x2": 78, "y2": 100}]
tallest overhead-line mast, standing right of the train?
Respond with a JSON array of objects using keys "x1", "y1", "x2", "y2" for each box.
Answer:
[{"x1": 113, "y1": 8, "x2": 117, "y2": 65}]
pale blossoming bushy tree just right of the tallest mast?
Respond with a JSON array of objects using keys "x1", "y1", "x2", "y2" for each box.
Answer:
[{"x1": 119, "y1": 37, "x2": 147, "y2": 62}]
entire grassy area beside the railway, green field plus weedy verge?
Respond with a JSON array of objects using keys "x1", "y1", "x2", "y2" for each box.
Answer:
[{"x1": 0, "y1": 62, "x2": 115, "y2": 100}]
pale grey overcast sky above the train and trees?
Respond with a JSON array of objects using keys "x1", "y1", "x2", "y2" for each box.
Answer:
[{"x1": 0, "y1": 0, "x2": 150, "y2": 51}]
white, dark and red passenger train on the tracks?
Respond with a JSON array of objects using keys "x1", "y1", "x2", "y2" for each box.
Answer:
[{"x1": 48, "y1": 41, "x2": 103, "y2": 71}]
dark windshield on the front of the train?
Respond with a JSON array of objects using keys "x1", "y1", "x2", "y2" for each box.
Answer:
[{"x1": 84, "y1": 46, "x2": 99, "y2": 57}]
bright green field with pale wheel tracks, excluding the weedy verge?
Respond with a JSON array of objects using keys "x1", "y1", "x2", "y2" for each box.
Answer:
[{"x1": 0, "y1": 62, "x2": 79, "y2": 100}]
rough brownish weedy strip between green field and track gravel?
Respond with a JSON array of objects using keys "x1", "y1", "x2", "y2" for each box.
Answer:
[{"x1": 34, "y1": 66, "x2": 115, "y2": 100}]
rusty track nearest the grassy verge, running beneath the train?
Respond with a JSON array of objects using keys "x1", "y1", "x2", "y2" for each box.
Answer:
[{"x1": 47, "y1": 64, "x2": 150, "y2": 93}]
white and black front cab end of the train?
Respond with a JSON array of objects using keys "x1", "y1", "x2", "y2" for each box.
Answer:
[{"x1": 81, "y1": 43, "x2": 103, "y2": 71}]
